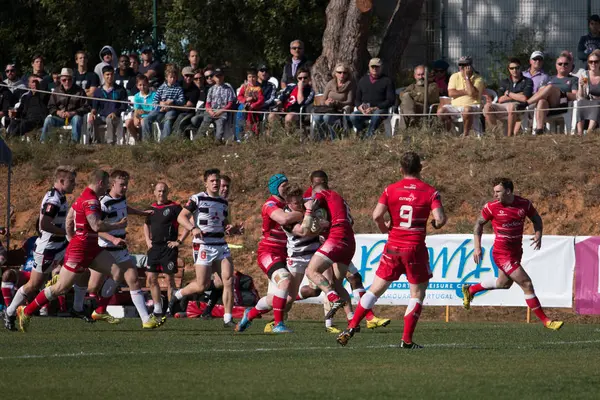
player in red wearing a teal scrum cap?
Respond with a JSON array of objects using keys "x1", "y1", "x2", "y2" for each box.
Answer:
[{"x1": 235, "y1": 174, "x2": 302, "y2": 333}]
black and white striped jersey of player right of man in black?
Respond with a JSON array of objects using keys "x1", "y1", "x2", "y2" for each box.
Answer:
[{"x1": 185, "y1": 192, "x2": 229, "y2": 246}]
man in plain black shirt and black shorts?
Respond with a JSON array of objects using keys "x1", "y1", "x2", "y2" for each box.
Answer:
[{"x1": 144, "y1": 182, "x2": 188, "y2": 318}]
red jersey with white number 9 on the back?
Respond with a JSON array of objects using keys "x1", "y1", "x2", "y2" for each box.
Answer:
[{"x1": 379, "y1": 178, "x2": 442, "y2": 246}]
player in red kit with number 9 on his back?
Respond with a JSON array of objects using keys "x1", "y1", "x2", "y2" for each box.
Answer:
[{"x1": 337, "y1": 152, "x2": 446, "y2": 349}]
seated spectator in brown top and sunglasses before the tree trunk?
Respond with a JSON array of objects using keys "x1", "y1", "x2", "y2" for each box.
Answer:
[{"x1": 313, "y1": 63, "x2": 356, "y2": 140}]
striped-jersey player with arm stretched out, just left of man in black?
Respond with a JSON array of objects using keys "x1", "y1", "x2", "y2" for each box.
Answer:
[{"x1": 89, "y1": 170, "x2": 165, "y2": 329}]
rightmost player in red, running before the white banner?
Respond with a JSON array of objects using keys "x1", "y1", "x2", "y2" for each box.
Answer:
[{"x1": 462, "y1": 178, "x2": 564, "y2": 331}]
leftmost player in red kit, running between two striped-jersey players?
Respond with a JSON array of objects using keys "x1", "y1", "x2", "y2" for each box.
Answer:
[{"x1": 17, "y1": 170, "x2": 127, "y2": 332}]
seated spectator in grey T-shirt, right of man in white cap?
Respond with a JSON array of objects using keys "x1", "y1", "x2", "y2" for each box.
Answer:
[{"x1": 527, "y1": 51, "x2": 577, "y2": 135}]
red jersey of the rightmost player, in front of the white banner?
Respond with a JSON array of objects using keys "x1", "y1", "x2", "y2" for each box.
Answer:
[{"x1": 481, "y1": 196, "x2": 537, "y2": 253}]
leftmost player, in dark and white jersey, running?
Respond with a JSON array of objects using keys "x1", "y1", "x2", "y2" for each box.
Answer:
[{"x1": 5, "y1": 165, "x2": 79, "y2": 326}]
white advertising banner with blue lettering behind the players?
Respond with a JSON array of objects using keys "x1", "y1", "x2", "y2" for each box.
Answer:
[{"x1": 305, "y1": 234, "x2": 575, "y2": 307}]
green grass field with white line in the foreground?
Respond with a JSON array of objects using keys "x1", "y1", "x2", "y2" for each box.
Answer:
[{"x1": 0, "y1": 318, "x2": 600, "y2": 399}]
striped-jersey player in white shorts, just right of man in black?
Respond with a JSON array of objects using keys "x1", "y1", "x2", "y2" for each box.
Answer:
[{"x1": 169, "y1": 169, "x2": 235, "y2": 328}]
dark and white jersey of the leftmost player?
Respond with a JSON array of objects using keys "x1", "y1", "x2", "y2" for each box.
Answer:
[{"x1": 35, "y1": 188, "x2": 69, "y2": 253}]
